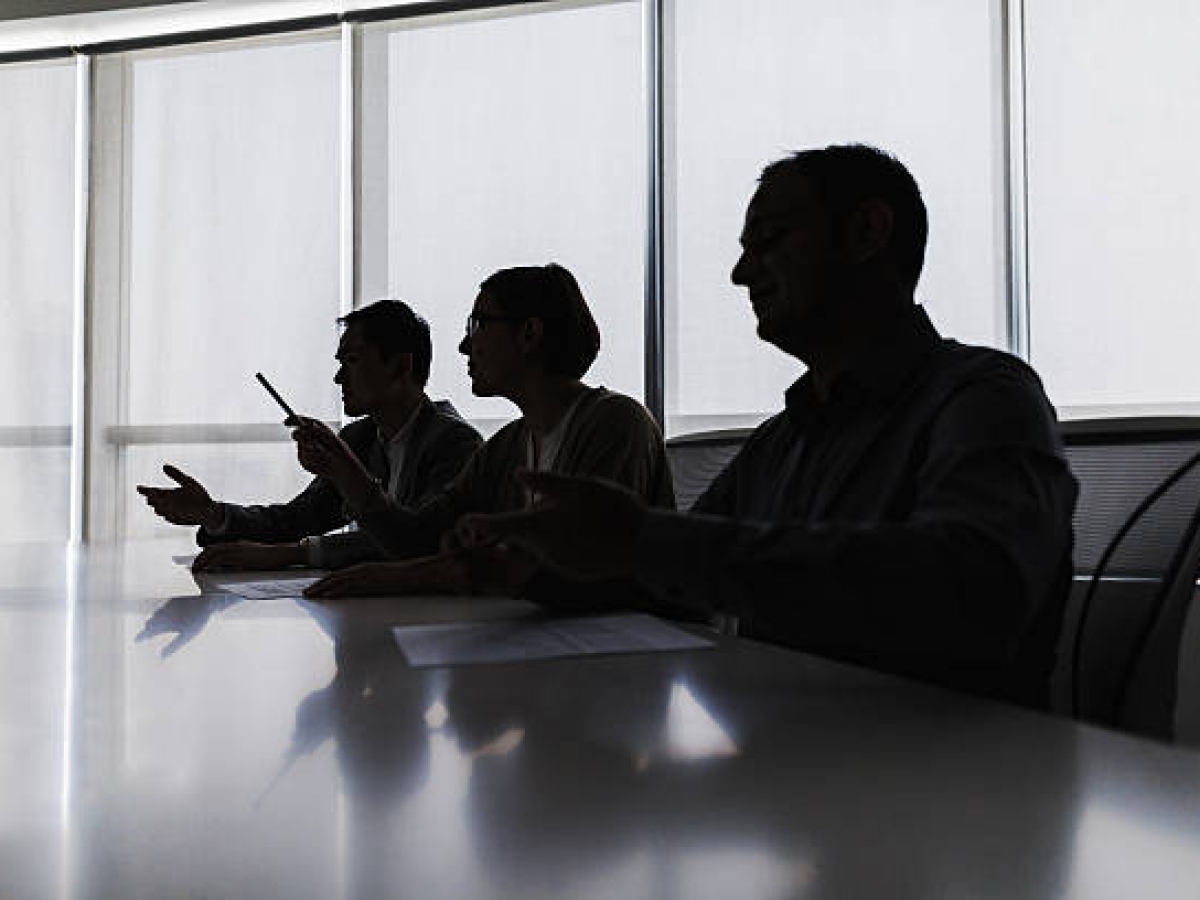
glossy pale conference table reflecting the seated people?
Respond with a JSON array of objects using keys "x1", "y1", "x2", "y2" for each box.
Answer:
[{"x1": 0, "y1": 540, "x2": 1200, "y2": 900}]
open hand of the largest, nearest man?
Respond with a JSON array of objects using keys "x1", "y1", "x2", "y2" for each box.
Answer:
[{"x1": 455, "y1": 472, "x2": 647, "y2": 578}]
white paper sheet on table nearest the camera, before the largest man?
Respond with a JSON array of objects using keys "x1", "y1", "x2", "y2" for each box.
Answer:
[{"x1": 392, "y1": 613, "x2": 712, "y2": 668}]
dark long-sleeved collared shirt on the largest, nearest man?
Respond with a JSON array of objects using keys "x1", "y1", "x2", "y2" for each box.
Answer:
[{"x1": 637, "y1": 306, "x2": 1076, "y2": 704}]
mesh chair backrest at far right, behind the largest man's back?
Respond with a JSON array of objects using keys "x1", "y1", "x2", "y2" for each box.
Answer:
[{"x1": 1056, "y1": 419, "x2": 1200, "y2": 738}]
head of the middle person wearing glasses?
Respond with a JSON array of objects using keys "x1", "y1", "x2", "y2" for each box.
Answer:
[{"x1": 458, "y1": 263, "x2": 600, "y2": 396}]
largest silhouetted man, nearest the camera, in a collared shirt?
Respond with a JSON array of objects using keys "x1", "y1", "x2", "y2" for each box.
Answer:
[{"x1": 457, "y1": 145, "x2": 1076, "y2": 706}]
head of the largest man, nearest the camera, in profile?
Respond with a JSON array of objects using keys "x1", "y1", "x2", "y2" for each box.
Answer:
[{"x1": 731, "y1": 144, "x2": 929, "y2": 353}]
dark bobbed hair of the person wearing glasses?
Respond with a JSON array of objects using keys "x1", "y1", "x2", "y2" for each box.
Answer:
[{"x1": 479, "y1": 263, "x2": 600, "y2": 378}]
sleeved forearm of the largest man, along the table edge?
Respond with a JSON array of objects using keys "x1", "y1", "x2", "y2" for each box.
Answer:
[{"x1": 635, "y1": 512, "x2": 1030, "y2": 658}]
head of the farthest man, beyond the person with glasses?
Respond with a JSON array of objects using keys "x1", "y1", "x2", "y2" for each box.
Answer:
[{"x1": 334, "y1": 300, "x2": 433, "y2": 416}]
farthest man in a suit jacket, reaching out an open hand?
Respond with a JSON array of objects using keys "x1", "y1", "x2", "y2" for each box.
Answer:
[{"x1": 138, "y1": 300, "x2": 481, "y2": 571}]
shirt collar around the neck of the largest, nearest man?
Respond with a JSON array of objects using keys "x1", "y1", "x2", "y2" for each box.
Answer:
[{"x1": 784, "y1": 304, "x2": 942, "y2": 416}]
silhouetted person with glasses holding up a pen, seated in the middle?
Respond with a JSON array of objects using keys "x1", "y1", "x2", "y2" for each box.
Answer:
[{"x1": 295, "y1": 263, "x2": 674, "y2": 598}]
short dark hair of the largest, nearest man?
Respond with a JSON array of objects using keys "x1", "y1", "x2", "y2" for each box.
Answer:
[{"x1": 758, "y1": 144, "x2": 929, "y2": 288}]
